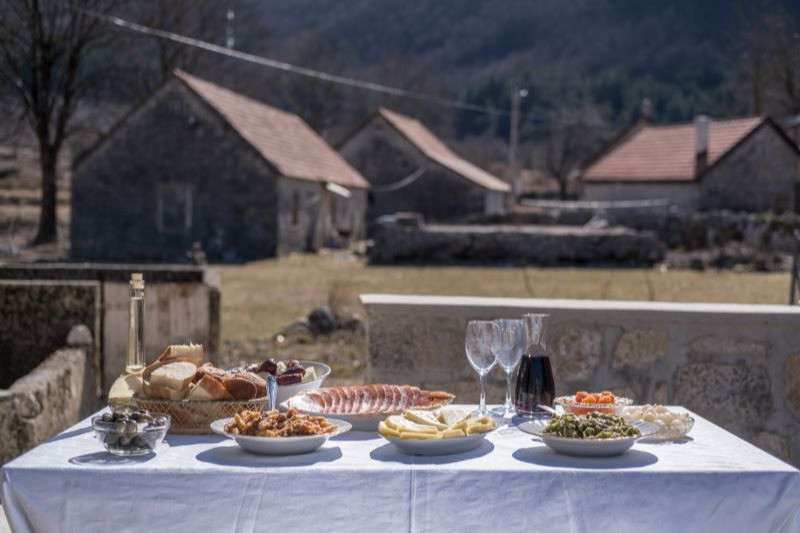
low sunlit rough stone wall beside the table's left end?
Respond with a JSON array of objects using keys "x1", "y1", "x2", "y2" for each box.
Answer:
[{"x1": 0, "y1": 330, "x2": 101, "y2": 464}]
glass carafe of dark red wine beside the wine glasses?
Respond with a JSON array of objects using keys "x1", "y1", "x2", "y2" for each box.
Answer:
[{"x1": 514, "y1": 314, "x2": 556, "y2": 417}]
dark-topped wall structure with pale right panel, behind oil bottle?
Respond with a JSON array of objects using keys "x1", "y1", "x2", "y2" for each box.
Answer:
[{"x1": 0, "y1": 263, "x2": 221, "y2": 391}]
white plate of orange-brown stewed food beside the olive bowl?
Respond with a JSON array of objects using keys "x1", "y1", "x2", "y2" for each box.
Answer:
[{"x1": 211, "y1": 409, "x2": 352, "y2": 455}]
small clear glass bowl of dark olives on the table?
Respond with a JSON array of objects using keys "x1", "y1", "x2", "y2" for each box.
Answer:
[{"x1": 92, "y1": 415, "x2": 170, "y2": 456}]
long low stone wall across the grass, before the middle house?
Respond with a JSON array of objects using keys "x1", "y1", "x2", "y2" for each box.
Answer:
[{"x1": 369, "y1": 224, "x2": 665, "y2": 265}]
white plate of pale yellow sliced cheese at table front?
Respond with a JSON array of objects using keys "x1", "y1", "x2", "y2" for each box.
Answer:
[{"x1": 378, "y1": 407, "x2": 497, "y2": 455}]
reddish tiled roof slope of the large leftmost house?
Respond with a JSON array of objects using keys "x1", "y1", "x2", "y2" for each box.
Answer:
[{"x1": 175, "y1": 70, "x2": 369, "y2": 188}]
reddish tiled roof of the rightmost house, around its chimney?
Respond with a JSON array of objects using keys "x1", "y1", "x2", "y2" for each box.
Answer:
[{"x1": 582, "y1": 117, "x2": 765, "y2": 182}]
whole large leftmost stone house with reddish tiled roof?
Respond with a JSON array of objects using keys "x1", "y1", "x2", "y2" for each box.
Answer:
[{"x1": 70, "y1": 70, "x2": 369, "y2": 261}]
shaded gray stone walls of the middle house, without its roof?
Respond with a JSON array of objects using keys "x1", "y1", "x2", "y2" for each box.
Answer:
[{"x1": 339, "y1": 118, "x2": 487, "y2": 221}]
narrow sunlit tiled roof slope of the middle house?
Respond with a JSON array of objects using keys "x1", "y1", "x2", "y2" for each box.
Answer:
[{"x1": 378, "y1": 108, "x2": 511, "y2": 192}]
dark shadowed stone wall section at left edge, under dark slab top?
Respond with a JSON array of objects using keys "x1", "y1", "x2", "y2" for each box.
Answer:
[{"x1": 0, "y1": 280, "x2": 102, "y2": 389}]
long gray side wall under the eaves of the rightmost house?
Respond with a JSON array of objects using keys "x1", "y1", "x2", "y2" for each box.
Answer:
[{"x1": 580, "y1": 182, "x2": 701, "y2": 209}]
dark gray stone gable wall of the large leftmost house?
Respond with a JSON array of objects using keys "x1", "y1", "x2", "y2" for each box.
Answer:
[{"x1": 71, "y1": 81, "x2": 278, "y2": 261}]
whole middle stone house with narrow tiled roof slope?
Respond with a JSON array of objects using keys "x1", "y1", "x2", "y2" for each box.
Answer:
[{"x1": 339, "y1": 108, "x2": 511, "y2": 221}]
